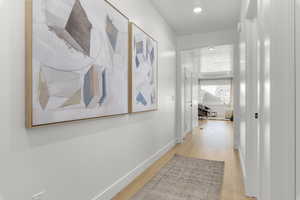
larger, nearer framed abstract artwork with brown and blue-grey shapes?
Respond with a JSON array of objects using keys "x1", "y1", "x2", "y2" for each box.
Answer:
[{"x1": 26, "y1": 0, "x2": 129, "y2": 128}]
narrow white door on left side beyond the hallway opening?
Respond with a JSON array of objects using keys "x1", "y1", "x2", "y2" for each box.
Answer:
[{"x1": 183, "y1": 68, "x2": 193, "y2": 138}]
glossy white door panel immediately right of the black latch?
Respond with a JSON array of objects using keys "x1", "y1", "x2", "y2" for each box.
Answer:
[{"x1": 257, "y1": 18, "x2": 271, "y2": 200}]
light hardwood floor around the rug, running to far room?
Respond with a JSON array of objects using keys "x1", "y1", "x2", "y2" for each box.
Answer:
[{"x1": 113, "y1": 121, "x2": 253, "y2": 200}]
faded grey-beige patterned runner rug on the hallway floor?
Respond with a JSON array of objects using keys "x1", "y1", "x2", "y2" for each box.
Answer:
[{"x1": 131, "y1": 155, "x2": 225, "y2": 200}]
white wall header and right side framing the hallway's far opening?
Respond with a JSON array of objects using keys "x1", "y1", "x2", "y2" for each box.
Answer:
[{"x1": 177, "y1": 30, "x2": 240, "y2": 148}]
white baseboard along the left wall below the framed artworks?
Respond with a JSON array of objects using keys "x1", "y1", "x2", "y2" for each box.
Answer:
[{"x1": 92, "y1": 140, "x2": 176, "y2": 200}]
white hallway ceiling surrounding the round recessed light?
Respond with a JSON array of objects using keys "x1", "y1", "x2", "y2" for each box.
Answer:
[{"x1": 152, "y1": 0, "x2": 241, "y2": 35}]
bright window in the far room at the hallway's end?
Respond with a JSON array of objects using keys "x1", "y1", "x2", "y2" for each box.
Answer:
[{"x1": 199, "y1": 79, "x2": 232, "y2": 105}]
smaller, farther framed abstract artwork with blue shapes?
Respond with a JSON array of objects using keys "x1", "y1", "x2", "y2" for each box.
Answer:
[{"x1": 129, "y1": 23, "x2": 158, "y2": 113}]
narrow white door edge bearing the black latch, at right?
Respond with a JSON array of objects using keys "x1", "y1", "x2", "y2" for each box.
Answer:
[{"x1": 246, "y1": 19, "x2": 259, "y2": 197}]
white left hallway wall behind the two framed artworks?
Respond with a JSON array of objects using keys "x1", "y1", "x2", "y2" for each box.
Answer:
[{"x1": 0, "y1": 0, "x2": 176, "y2": 200}]
